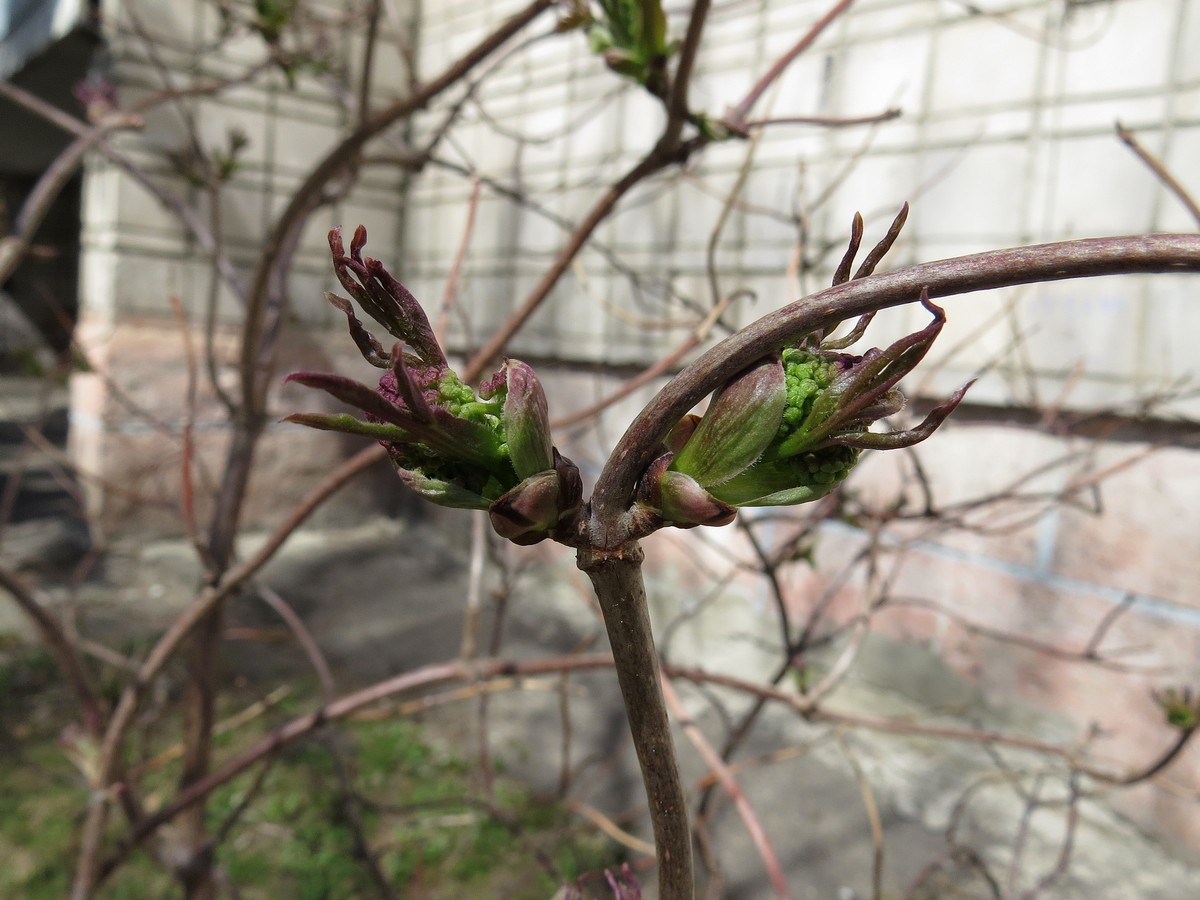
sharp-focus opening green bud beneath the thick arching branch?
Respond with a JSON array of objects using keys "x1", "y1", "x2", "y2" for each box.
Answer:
[{"x1": 638, "y1": 300, "x2": 970, "y2": 528}]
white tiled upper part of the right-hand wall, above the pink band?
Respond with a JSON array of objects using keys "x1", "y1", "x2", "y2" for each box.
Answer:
[{"x1": 407, "y1": 0, "x2": 1200, "y2": 414}]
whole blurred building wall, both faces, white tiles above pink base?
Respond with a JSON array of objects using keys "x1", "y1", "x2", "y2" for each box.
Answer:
[{"x1": 60, "y1": 0, "x2": 1200, "y2": 859}]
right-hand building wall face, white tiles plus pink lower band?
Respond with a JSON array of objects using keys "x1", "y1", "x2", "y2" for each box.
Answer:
[{"x1": 404, "y1": 0, "x2": 1200, "y2": 846}]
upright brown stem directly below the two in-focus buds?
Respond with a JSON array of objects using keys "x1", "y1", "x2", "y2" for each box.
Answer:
[{"x1": 578, "y1": 541, "x2": 694, "y2": 900}]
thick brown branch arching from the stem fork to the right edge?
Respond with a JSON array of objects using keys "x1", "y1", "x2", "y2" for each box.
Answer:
[{"x1": 589, "y1": 234, "x2": 1200, "y2": 548}]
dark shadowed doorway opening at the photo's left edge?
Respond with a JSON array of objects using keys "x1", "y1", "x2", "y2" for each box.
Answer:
[{"x1": 0, "y1": 24, "x2": 98, "y2": 577}]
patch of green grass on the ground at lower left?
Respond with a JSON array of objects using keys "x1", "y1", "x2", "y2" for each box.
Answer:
[{"x1": 0, "y1": 654, "x2": 619, "y2": 900}]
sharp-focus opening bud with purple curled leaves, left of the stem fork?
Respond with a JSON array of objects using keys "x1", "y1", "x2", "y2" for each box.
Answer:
[{"x1": 287, "y1": 227, "x2": 583, "y2": 544}]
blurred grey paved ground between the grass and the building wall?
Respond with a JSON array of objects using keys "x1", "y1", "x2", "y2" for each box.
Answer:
[{"x1": 7, "y1": 514, "x2": 1200, "y2": 900}]
